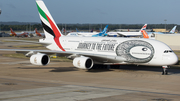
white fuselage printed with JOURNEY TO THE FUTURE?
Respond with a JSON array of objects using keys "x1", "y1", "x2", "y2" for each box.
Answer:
[{"x1": 41, "y1": 36, "x2": 178, "y2": 66}]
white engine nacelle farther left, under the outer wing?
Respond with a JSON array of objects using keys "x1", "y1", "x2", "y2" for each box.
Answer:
[{"x1": 30, "y1": 53, "x2": 50, "y2": 66}]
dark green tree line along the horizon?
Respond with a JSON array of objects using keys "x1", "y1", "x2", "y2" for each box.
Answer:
[{"x1": 0, "y1": 23, "x2": 180, "y2": 31}]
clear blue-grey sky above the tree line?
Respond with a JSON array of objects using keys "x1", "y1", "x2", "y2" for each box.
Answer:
[{"x1": 0, "y1": 0, "x2": 180, "y2": 24}]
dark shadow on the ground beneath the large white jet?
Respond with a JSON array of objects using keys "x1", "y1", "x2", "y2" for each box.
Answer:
[{"x1": 17, "y1": 65, "x2": 180, "y2": 75}]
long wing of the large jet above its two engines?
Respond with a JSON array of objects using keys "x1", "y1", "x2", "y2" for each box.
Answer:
[{"x1": 0, "y1": 49, "x2": 126, "y2": 64}]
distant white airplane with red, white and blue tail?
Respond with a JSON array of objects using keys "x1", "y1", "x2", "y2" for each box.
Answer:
[{"x1": 107, "y1": 24, "x2": 147, "y2": 37}]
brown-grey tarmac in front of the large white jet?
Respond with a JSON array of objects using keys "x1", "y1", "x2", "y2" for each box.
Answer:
[{"x1": 0, "y1": 37, "x2": 180, "y2": 101}]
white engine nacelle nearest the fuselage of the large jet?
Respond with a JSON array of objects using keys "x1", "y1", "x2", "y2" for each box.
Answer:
[{"x1": 73, "y1": 57, "x2": 93, "y2": 69}]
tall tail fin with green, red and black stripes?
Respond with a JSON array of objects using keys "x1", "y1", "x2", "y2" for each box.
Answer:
[{"x1": 36, "y1": 0, "x2": 62, "y2": 38}]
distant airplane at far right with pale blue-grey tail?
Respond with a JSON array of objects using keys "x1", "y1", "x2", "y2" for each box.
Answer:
[{"x1": 147, "y1": 26, "x2": 177, "y2": 38}]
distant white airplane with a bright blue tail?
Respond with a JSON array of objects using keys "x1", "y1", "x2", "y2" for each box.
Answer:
[{"x1": 67, "y1": 25, "x2": 108, "y2": 37}]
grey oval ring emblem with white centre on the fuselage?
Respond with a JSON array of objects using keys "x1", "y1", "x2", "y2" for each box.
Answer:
[{"x1": 116, "y1": 40, "x2": 154, "y2": 63}]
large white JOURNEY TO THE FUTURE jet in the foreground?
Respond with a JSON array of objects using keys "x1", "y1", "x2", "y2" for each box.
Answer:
[{"x1": 0, "y1": 0, "x2": 178, "y2": 74}]
